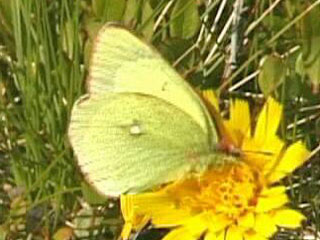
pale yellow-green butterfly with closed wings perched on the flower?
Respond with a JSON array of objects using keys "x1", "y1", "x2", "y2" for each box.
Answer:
[{"x1": 68, "y1": 24, "x2": 238, "y2": 197}]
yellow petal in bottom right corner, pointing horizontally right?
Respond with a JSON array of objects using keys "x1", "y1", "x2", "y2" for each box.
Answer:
[{"x1": 273, "y1": 209, "x2": 306, "y2": 228}]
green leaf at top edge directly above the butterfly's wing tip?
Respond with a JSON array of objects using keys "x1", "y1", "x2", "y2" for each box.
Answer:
[{"x1": 92, "y1": 0, "x2": 126, "y2": 22}]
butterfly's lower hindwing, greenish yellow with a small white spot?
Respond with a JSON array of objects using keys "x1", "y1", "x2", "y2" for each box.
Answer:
[{"x1": 69, "y1": 93, "x2": 215, "y2": 196}]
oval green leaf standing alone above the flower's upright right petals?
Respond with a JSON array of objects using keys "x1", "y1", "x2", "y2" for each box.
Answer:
[{"x1": 258, "y1": 55, "x2": 286, "y2": 96}]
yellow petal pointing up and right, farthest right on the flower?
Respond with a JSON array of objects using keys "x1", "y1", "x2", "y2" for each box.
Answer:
[{"x1": 268, "y1": 141, "x2": 309, "y2": 183}]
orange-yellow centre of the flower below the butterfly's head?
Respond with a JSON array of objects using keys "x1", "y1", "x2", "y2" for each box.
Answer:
[{"x1": 175, "y1": 163, "x2": 262, "y2": 219}]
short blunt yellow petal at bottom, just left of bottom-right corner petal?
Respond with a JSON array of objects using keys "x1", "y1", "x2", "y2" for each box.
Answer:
[{"x1": 254, "y1": 213, "x2": 278, "y2": 238}]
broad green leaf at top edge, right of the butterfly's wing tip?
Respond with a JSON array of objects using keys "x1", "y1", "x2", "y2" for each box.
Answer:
[{"x1": 170, "y1": 0, "x2": 200, "y2": 39}]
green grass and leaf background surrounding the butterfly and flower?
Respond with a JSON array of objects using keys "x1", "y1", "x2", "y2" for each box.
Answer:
[{"x1": 0, "y1": 0, "x2": 320, "y2": 240}]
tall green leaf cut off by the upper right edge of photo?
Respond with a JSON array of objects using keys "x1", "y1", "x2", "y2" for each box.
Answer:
[{"x1": 301, "y1": 5, "x2": 320, "y2": 93}]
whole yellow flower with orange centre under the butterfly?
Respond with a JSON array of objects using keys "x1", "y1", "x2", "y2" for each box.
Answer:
[{"x1": 121, "y1": 95, "x2": 309, "y2": 240}]
